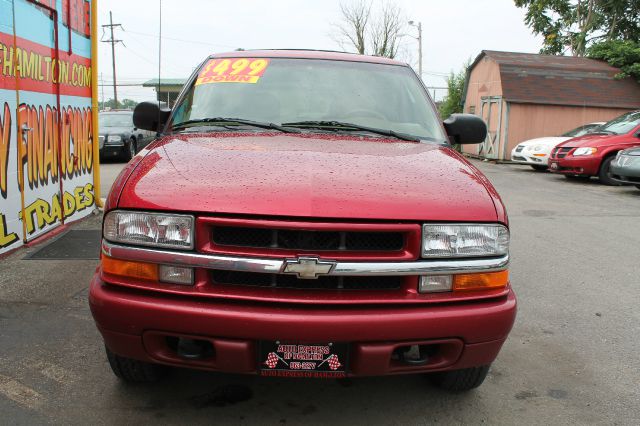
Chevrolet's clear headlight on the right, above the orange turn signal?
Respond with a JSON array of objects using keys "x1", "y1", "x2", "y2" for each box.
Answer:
[{"x1": 422, "y1": 224, "x2": 509, "y2": 257}]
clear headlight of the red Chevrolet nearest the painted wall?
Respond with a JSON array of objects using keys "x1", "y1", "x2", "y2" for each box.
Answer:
[{"x1": 103, "y1": 210, "x2": 194, "y2": 250}]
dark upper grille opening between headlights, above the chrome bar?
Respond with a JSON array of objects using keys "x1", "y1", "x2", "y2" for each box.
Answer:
[{"x1": 211, "y1": 226, "x2": 405, "y2": 251}]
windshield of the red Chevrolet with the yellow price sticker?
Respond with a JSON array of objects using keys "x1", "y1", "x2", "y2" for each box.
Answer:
[{"x1": 171, "y1": 58, "x2": 446, "y2": 142}]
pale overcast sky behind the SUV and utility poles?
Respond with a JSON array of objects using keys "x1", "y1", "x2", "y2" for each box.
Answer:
[{"x1": 98, "y1": 0, "x2": 541, "y2": 101}]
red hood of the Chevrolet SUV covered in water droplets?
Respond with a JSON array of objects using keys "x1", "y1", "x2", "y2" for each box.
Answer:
[{"x1": 118, "y1": 132, "x2": 497, "y2": 222}]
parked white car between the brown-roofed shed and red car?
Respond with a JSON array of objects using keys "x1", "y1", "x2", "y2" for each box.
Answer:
[{"x1": 511, "y1": 121, "x2": 604, "y2": 170}]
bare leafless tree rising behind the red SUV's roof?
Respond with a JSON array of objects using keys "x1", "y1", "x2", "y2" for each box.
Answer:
[{"x1": 334, "y1": 0, "x2": 405, "y2": 58}]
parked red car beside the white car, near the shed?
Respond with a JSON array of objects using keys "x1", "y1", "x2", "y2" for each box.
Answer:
[{"x1": 549, "y1": 111, "x2": 640, "y2": 185}]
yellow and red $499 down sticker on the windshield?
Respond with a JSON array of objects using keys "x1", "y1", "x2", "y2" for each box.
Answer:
[{"x1": 196, "y1": 58, "x2": 269, "y2": 86}]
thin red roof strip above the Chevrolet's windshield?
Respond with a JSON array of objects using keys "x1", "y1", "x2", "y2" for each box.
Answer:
[{"x1": 211, "y1": 49, "x2": 406, "y2": 65}]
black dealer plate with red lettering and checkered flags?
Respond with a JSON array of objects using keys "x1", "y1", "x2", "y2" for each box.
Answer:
[{"x1": 258, "y1": 341, "x2": 349, "y2": 378}]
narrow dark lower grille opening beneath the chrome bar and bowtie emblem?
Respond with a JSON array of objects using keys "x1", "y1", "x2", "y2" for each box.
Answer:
[{"x1": 212, "y1": 270, "x2": 404, "y2": 290}]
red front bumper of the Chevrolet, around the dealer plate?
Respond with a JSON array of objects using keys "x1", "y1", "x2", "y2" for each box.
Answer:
[{"x1": 89, "y1": 274, "x2": 516, "y2": 376}]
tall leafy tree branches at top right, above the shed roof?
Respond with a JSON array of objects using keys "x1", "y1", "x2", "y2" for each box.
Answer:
[{"x1": 514, "y1": 0, "x2": 640, "y2": 56}]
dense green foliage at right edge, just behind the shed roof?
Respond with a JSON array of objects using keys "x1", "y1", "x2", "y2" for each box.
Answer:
[{"x1": 587, "y1": 40, "x2": 640, "y2": 83}]
